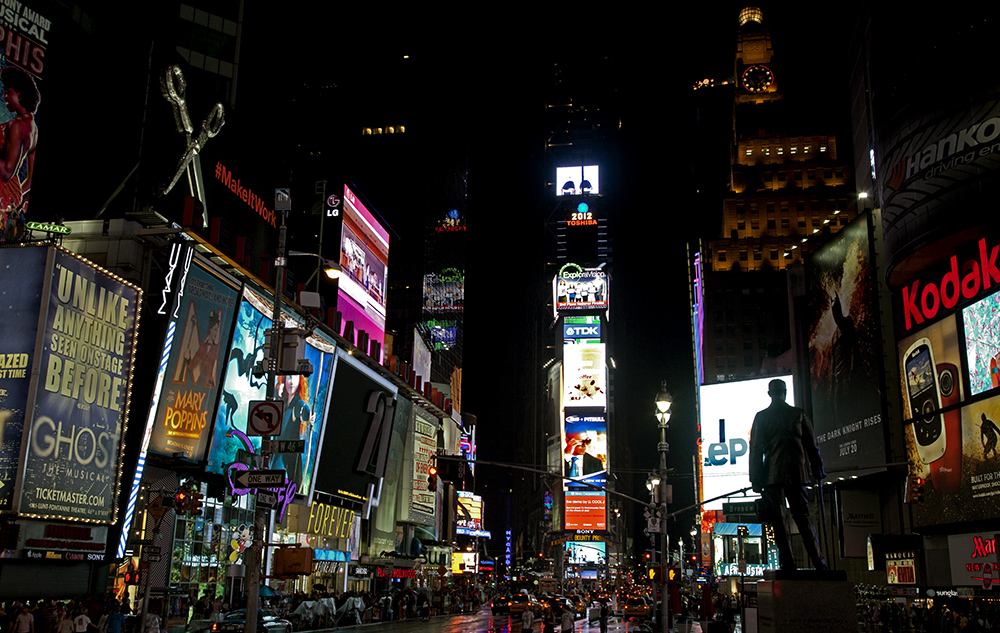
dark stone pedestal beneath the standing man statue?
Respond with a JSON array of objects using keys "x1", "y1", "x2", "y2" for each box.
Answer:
[{"x1": 757, "y1": 570, "x2": 858, "y2": 633}]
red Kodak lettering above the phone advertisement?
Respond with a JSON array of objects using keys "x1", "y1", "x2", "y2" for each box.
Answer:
[{"x1": 903, "y1": 238, "x2": 1000, "y2": 330}]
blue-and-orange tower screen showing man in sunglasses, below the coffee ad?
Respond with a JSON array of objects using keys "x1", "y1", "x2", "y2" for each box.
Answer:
[{"x1": 562, "y1": 409, "x2": 608, "y2": 530}]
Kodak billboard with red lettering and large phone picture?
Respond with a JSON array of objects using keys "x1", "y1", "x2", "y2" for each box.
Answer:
[{"x1": 894, "y1": 231, "x2": 1000, "y2": 525}]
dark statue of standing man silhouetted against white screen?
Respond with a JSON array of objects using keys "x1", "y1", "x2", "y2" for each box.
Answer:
[{"x1": 750, "y1": 380, "x2": 826, "y2": 570}]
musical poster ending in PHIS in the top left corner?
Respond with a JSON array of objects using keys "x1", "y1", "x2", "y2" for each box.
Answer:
[{"x1": 0, "y1": 2, "x2": 52, "y2": 244}]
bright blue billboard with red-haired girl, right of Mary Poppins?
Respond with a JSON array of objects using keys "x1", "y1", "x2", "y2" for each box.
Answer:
[{"x1": 206, "y1": 288, "x2": 336, "y2": 496}]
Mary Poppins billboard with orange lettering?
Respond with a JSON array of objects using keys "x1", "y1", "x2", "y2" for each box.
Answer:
[{"x1": 149, "y1": 250, "x2": 239, "y2": 461}]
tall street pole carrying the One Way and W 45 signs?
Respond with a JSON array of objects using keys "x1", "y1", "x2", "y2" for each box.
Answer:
[{"x1": 243, "y1": 190, "x2": 291, "y2": 633}]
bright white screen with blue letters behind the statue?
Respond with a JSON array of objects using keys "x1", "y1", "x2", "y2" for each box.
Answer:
[{"x1": 699, "y1": 376, "x2": 792, "y2": 510}]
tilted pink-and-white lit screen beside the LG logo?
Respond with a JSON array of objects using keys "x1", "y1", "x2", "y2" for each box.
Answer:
[{"x1": 337, "y1": 185, "x2": 389, "y2": 358}]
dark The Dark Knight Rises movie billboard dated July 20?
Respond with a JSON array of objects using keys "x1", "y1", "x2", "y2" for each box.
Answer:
[{"x1": 805, "y1": 216, "x2": 885, "y2": 477}]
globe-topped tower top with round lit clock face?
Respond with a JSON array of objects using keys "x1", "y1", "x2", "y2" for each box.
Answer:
[{"x1": 734, "y1": 7, "x2": 781, "y2": 103}]
